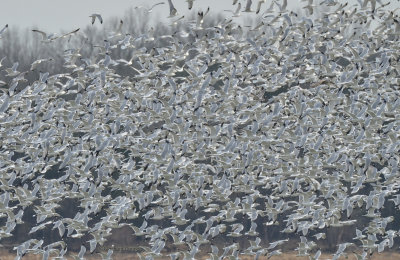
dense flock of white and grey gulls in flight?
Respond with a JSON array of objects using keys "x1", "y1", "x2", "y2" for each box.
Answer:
[{"x1": 0, "y1": 0, "x2": 400, "y2": 260}]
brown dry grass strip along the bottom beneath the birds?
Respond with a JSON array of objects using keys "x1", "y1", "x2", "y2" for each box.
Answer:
[{"x1": 0, "y1": 250, "x2": 400, "y2": 260}]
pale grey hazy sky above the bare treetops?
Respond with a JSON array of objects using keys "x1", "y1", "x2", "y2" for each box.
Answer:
[{"x1": 0, "y1": 0, "x2": 400, "y2": 33}]
